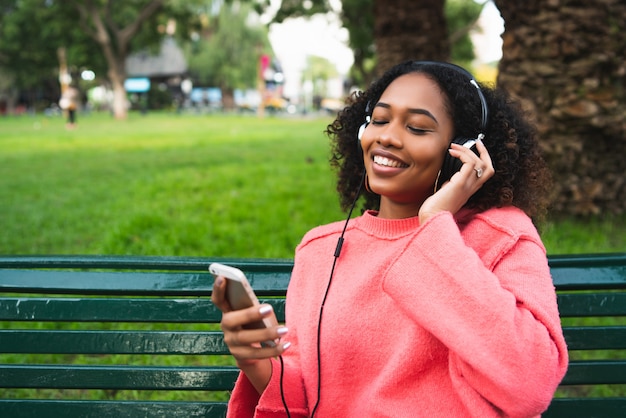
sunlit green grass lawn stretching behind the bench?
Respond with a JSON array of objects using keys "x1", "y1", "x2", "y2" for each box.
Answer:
[{"x1": 0, "y1": 109, "x2": 626, "y2": 258}]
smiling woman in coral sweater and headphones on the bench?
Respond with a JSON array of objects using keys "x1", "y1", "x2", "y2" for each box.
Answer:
[{"x1": 213, "y1": 62, "x2": 568, "y2": 418}]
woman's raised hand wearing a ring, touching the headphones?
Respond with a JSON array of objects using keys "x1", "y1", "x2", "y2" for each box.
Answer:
[{"x1": 418, "y1": 140, "x2": 495, "y2": 224}]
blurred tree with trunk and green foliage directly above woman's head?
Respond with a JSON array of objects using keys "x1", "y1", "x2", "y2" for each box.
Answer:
[{"x1": 252, "y1": 0, "x2": 486, "y2": 86}]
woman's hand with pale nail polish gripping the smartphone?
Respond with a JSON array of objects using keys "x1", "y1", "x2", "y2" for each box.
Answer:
[{"x1": 211, "y1": 276, "x2": 290, "y2": 393}]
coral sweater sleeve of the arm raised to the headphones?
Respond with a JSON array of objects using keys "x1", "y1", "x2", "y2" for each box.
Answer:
[{"x1": 383, "y1": 213, "x2": 568, "y2": 417}]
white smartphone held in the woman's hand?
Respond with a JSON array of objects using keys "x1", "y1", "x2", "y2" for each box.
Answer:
[{"x1": 209, "y1": 263, "x2": 278, "y2": 347}]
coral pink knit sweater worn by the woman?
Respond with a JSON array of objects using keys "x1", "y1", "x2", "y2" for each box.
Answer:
[{"x1": 228, "y1": 207, "x2": 568, "y2": 418}]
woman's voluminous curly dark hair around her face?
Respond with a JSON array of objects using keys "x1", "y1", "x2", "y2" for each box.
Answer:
[{"x1": 325, "y1": 61, "x2": 551, "y2": 224}]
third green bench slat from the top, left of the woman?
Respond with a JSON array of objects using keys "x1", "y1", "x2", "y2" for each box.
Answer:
[{"x1": 0, "y1": 297, "x2": 285, "y2": 323}]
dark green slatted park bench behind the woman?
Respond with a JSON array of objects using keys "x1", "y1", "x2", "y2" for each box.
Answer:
[{"x1": 0, "y1": 254, "x2": 626, "y2": 418}]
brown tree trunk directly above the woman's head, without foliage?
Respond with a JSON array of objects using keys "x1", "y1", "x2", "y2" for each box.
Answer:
[{"x1": 374, "y1": 0, "x2": 450, "y2": 76}]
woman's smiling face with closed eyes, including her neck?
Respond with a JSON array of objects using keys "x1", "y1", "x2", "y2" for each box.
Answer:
[{"x1": 361, "y1": 73, "x2": 453, "y2": 218}]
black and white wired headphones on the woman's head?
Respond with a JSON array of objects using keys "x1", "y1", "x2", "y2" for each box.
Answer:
[{"x1": 357, "y1": 61, "x2": 489, "y2": 191}]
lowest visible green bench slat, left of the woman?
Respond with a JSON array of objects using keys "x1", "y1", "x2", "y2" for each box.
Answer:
[{"x1": 0, "y1": 399, "x2": 226, "y2": 418}]
